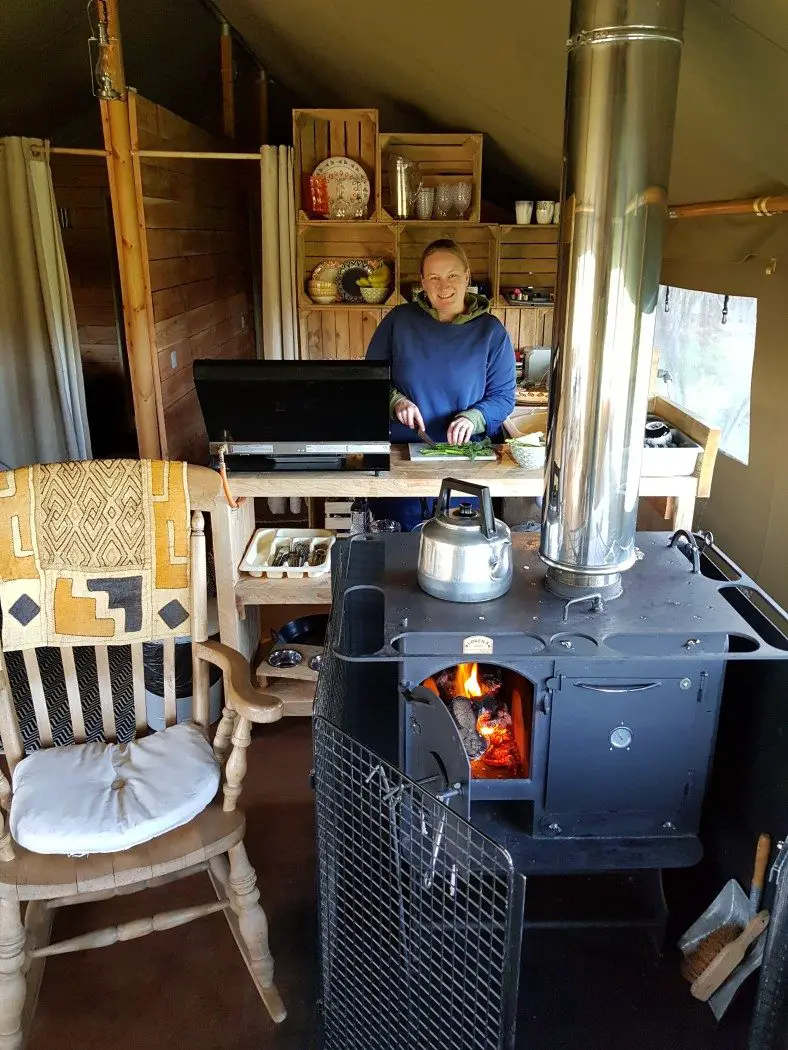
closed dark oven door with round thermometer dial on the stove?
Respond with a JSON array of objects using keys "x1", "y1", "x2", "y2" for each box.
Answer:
[{"x1": 545, "y1": 675, "x2": 700, "y2": 832}]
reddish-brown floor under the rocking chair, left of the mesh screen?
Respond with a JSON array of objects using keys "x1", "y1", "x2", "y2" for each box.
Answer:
[{"x1": 28, "y1": 718, "x2": 316, "y2": 1050}]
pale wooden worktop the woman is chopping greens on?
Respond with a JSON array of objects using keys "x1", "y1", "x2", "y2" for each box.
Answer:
[{"x1": 224, "y1": 445, "x2": 698, "y2": 499}]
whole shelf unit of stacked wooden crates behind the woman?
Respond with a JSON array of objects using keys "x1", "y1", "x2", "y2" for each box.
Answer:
[{"x1": 293, "y1": 109, "x2": 559, "y2": 360}]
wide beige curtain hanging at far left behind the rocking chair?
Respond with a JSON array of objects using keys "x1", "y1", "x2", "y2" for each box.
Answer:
[{"x1": 0, "y1": 138, "x2": 90, "y2": 467}]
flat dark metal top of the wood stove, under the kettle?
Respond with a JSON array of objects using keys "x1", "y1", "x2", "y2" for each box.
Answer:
[{"x1": 334, "y1": 532, "x2": 788, "y2": 659}]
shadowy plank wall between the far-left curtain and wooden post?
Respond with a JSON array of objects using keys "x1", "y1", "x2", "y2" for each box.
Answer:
[{"x1": 50, "y1": 154, "x2": 123, "y2": 377}]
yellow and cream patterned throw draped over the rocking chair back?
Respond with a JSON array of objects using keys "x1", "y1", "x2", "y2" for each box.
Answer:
[{"x1": 0, "y1": 460, "x2": 190, "y2": 651}]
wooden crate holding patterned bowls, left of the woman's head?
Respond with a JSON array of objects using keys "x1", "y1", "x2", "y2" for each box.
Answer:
[{"x1": 296, "y1": 221, "x2": 398, "y2": 310}]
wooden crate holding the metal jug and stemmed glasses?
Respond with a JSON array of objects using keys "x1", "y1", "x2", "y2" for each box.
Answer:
[{"x1": 380, "y1": 132, "x2": 483, "y2": 223}]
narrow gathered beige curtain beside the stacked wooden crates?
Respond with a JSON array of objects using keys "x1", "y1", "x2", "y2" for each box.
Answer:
[{"x1": 261, "y1": 146, "x2": 298, "y2": 361}]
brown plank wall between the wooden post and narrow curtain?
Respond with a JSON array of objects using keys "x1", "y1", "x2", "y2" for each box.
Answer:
[{"x1": 136, "y1": 97, "x2": 254, "y2": 463}]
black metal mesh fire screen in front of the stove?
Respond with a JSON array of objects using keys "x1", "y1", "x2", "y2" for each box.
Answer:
[{"x1": 314, "y1": 718, "x2": 524, "y2": 1050}]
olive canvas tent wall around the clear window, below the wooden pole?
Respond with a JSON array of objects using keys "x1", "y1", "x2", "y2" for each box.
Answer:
[{"x1": 662, "y1": 217, "x2": 788, "y2": 606}]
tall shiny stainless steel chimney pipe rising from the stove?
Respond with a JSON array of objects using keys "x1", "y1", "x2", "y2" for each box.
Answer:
[{"x1": 540, "y1": 0, "x2": 684, "y2": 597}]
